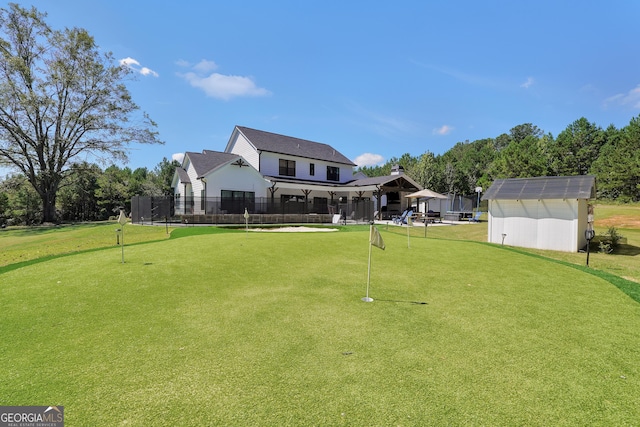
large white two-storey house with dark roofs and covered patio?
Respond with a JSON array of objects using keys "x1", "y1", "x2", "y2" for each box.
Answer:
[{"x1": 166, "y1": 126, "x2": 421, "y2": 223}]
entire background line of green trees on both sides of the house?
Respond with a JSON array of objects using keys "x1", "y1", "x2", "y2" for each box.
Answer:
[{"x1": 0, "y1": 116, "x2": 640, "y2": 224}]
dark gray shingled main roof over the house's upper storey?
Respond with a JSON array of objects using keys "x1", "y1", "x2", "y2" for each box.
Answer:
[{"x1": 236, "y1": 126, "x2": 356, "y2": 166}]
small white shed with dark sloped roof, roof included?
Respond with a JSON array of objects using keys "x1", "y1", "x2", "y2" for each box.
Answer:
[{"x1": 482, "y1": 175, "x2": 596, "y2": 252}]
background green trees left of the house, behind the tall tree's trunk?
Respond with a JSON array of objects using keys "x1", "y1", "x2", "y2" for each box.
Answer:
[{"x1": 0, "y1": 158, "x2": 180, "y2": 225}]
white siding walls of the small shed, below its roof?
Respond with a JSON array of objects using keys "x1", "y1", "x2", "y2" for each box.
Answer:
[{"x1": 488, "y1": 199, "x2": 586, "y2": 252}]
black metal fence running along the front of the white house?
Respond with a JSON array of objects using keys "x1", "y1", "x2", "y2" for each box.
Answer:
[{"x1": 131, "y1": 196, "x2": 374, "y2": 224}]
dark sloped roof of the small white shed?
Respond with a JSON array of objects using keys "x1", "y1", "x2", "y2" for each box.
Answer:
[{"x1": 482, "y1": 175, "x2": 596, "y2": 200}]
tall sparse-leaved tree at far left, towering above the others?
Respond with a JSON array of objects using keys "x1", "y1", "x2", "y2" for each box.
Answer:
[{"x1": 0, "y1": 3, "x2": 160, "y2": 221}]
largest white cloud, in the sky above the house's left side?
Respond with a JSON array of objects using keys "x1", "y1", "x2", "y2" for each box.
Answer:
[{"x1": 178, "y1": 59, "x2": 271, "y2": 101}]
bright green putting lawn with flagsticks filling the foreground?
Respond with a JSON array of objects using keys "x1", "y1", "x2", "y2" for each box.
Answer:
[{"x1": 0, "y1": 224, "x2": 640, "y2": 426}]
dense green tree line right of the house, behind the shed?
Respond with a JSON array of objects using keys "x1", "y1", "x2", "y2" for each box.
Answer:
[{"x1": 359, "y1": 116, "x2": 640, "y2": 203}]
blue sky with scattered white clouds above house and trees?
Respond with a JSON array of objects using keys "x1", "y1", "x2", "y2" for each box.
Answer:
[{"x1": 11, "y1": 0, "x2": 640, "y2": 169}]
